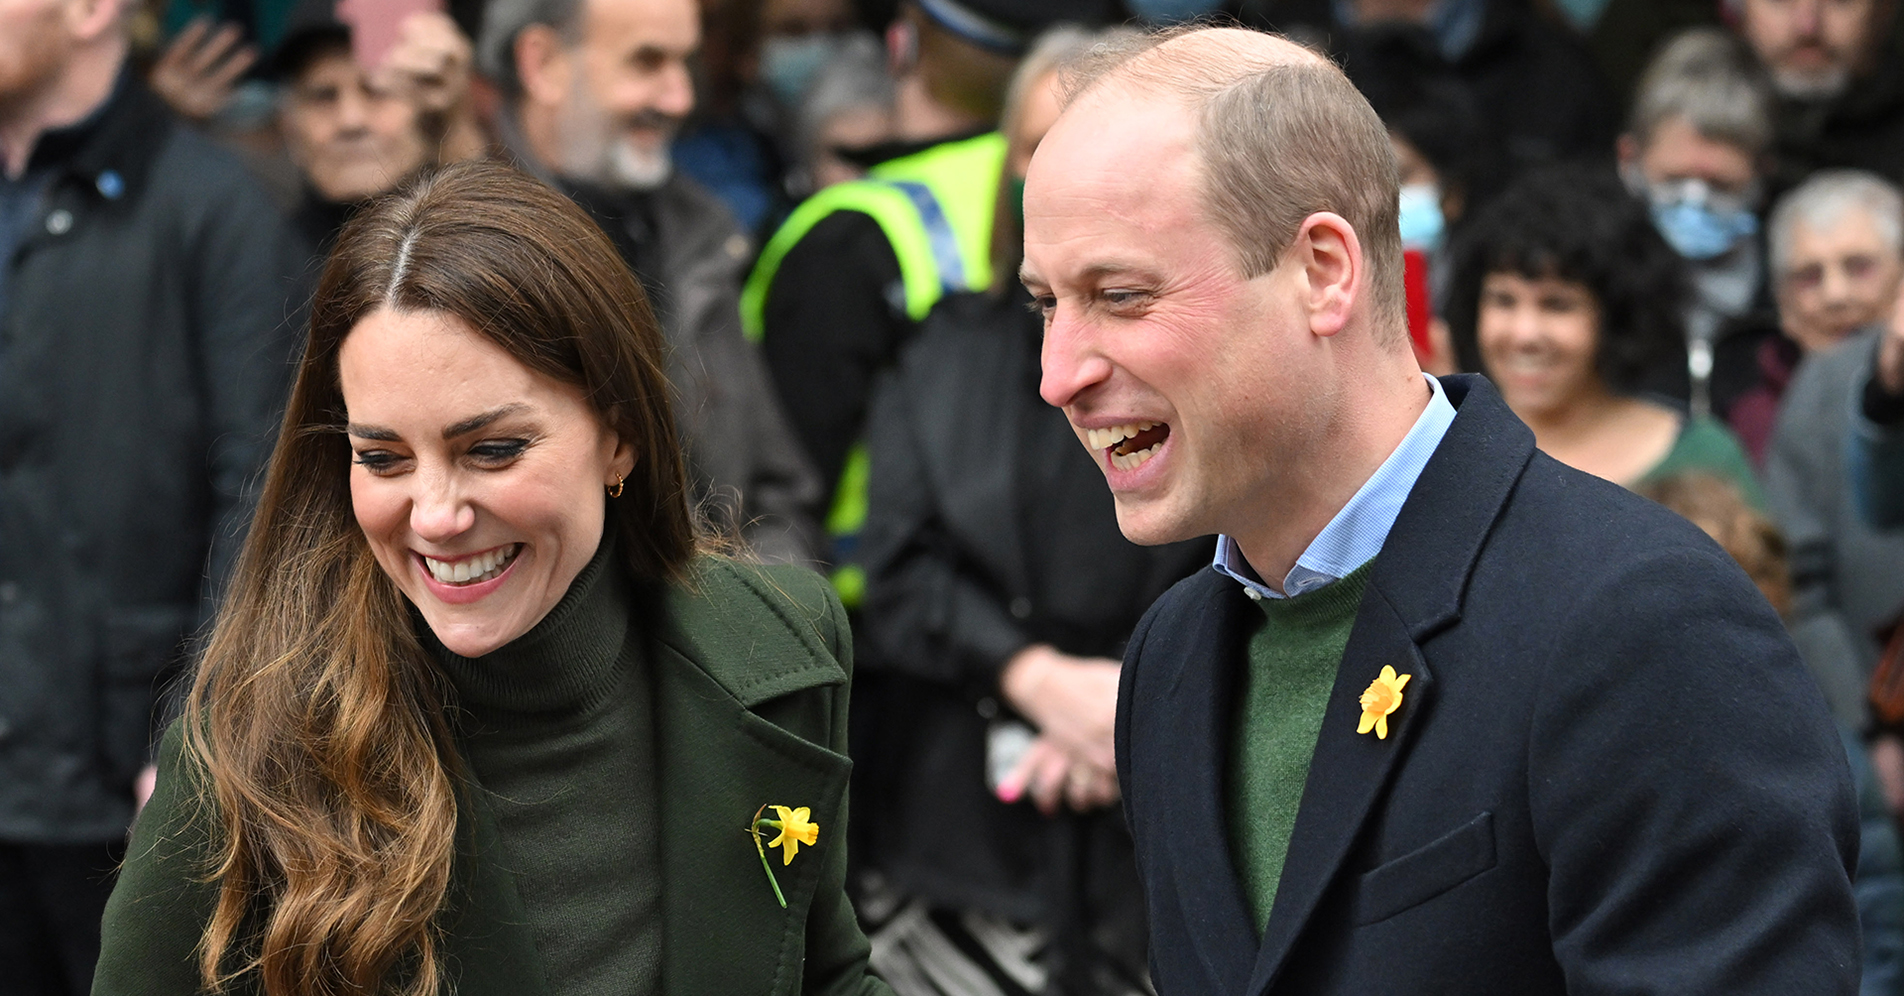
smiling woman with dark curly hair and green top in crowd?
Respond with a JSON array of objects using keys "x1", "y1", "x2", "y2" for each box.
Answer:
[{"x1": 1447, "y1": 168, "x2": 1763, "y2": 507}]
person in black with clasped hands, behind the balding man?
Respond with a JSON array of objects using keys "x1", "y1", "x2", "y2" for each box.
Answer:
[{"x1": 861, "y1": 21, "x2": 1211, "y2": 996}]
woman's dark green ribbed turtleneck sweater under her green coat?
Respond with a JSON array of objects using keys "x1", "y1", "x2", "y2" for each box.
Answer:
[{"x1": 426, "y1": 541, "x2": 661, "y2": 996}]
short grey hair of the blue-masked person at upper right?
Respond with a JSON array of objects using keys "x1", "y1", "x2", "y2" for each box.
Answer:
[{"x1": 1628, "y1": 29, "x2": 1773, "y2": 156}]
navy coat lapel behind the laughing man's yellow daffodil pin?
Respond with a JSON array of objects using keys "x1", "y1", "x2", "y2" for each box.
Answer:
[{"x1": 1224, "y1": 375, "x2": 1535, "y2": 994}]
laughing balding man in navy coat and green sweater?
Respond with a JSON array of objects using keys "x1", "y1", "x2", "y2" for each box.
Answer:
[{"x1": 1022, "y1": 29, "x2": 1858, "y2": 996}]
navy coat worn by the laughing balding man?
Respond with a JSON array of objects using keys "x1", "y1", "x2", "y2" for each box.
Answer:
[{"x1": 1118, "y1": 377, "x2": 1858, "y2": 996}]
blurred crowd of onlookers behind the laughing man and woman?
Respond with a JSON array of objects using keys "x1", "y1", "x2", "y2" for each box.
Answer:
[{"x1": 0, "y1": 0, "x2": 1904, "y2": 996}]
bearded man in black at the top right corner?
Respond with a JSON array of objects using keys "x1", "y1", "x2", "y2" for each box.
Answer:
[{"x1": 1727, "y1": 0, "x2": 1904, "y2": 194}]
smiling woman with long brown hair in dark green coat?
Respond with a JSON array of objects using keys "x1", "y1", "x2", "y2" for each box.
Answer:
[{"x1": 95, "y1": 164, "x2": 883, "y2": 996}]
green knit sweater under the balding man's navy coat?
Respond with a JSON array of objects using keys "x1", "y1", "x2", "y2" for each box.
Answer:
[{"x1": 1228, "y1": 564, "x2": 1369, "y2": 933}]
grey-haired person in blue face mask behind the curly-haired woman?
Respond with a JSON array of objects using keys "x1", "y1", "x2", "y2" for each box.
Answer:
[{"x1": 1616, "y1": 29, "x2": 1776, "y2": 417}]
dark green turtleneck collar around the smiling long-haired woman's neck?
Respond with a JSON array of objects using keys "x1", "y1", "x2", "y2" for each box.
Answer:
[{"x1": 417, "y1": 537, "x2": 630, "y2": 714}]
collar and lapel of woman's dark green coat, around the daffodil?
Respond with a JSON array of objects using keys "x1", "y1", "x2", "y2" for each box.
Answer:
[{"x1": 655, "y1": 571, "x2": 851, "y2": 994}]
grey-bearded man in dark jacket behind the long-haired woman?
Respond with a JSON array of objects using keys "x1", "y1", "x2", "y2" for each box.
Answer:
[{"x1": 478, "y1": 0, "x2": 821, "y2": 562}]
